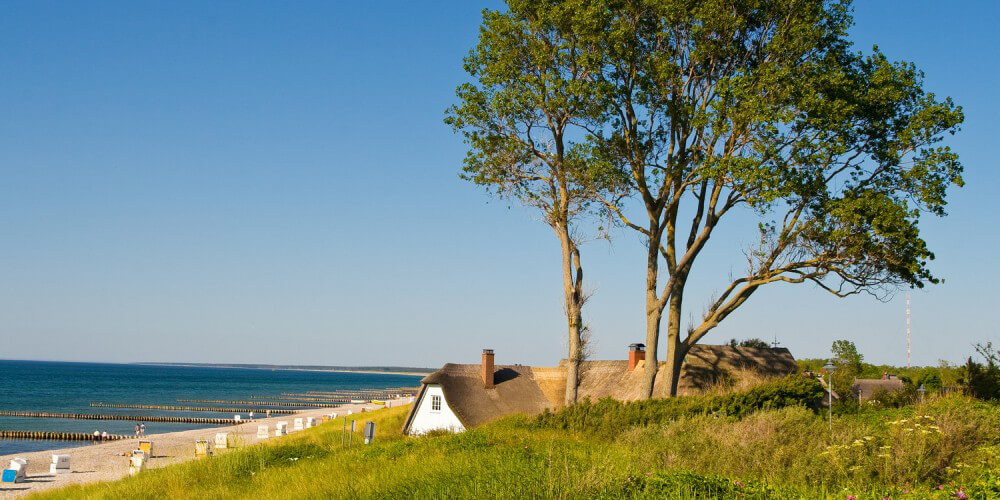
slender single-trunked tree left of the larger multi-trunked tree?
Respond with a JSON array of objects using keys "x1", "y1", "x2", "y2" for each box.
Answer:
[{"x1": 446, "y1": 0, "x2": 608, "y2": 404}]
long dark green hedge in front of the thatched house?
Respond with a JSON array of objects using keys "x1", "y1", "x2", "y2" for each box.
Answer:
[{"x1": 534, "y1": 375, "x2": 825, "y2": 435}]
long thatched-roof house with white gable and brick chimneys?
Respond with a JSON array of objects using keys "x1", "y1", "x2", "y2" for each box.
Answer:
[{"x1": 403, "y1": 344, "x2": 797, "y2": 434}]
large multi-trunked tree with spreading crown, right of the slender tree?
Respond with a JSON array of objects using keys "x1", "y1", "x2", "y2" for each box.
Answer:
[{"x1": 589, "y1": 0, "x2": 963, "y2": 396}]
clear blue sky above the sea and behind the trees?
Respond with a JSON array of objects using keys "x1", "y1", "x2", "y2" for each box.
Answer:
[{"x1": 0, "y1": 0, "x2": 1000, "y2": 366}]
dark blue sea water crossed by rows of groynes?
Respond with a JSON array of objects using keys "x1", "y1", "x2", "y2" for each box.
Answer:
[{"x1": 0, "y1": 360, "x2": 421, "y2": 455}]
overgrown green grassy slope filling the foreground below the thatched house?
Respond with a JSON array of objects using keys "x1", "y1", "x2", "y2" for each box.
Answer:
[{"x1": 39, "y1": 377, "x2": 1000, "y2": 499}]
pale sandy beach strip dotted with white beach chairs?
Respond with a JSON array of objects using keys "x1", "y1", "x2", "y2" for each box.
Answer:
[{"x1": 0, "y1": 398, "x2": 409, "y2": 498}]
